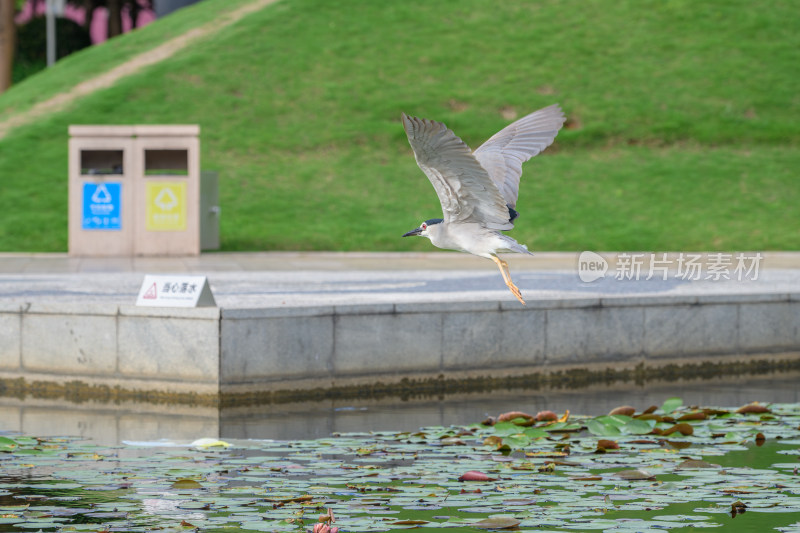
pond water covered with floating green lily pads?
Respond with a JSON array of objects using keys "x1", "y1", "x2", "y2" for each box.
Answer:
[{"x1": 0, "y1": 392, "x2": 800, "y2": 533}]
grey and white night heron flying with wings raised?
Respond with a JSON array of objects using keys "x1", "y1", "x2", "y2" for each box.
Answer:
[{"x1": 403, "y1": 104, "x2": 565, "y2": 305}]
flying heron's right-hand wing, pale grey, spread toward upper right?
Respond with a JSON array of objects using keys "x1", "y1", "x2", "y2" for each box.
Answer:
[{"x1": 474, "y1": 104, "x2": 566, "y2": 207}]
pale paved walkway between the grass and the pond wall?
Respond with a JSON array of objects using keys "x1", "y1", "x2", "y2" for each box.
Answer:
[{"x1": 0, "y1": 252, "x2": 800, "y2": 308}]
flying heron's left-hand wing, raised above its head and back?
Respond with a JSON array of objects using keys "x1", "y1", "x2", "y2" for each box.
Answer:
[{"x1": 403, "y1": 113, "x2": 514, "y2": 230}]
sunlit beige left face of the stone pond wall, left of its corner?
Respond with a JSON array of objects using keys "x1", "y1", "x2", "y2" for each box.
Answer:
[{"x1": 0, "y1": 302, "x2": 220, "y2": 393}]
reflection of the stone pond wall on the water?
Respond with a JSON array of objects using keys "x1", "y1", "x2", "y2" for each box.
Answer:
[{"x1": 0, "y1": 374, "x2": 800, "y2": 445}]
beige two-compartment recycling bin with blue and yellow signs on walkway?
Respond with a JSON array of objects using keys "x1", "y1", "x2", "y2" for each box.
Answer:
[{"x1": 69, "y1": 125, "x2": 219, "y2": 256}]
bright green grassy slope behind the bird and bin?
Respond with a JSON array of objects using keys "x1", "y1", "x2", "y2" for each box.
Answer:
[{"x1": 0, "y1": 0, "x2": 800, "y2": 251}]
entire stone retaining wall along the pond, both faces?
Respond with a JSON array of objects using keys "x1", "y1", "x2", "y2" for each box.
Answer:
[{"x1": 0, "y1": 292, "x2": 800, "y2": 397}]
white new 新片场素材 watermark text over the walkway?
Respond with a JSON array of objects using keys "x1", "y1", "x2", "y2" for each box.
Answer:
[{"x1": 578, "y1": 251, "x2": 764, "y2": 283}]
